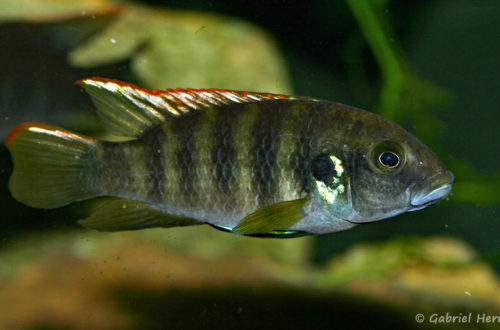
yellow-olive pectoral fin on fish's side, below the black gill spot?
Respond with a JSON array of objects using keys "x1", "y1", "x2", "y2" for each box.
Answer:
[{"x1": 232, "y1": 197, "x2": 310, "y2": 235}]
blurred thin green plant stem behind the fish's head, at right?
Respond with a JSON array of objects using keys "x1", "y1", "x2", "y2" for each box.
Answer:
[{"x1": 347, "y1": 0, "x2": 500, "y2": 204}]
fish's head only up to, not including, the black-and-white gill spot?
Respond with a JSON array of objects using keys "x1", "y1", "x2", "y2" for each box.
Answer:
[{"x1": 346, "y1": 115, "x2": 454, "y2": 223}]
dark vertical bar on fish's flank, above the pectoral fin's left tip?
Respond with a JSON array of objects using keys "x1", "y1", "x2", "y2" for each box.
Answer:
[{"x1": 211, "y1": 105, "x2": 241, "y2": 204}]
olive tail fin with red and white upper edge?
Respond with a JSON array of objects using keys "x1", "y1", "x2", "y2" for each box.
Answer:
[{"x1": 5, "y1": 122, "x2": 97, "y2": 209}]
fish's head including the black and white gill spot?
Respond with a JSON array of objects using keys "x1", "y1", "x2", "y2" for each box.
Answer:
[{"x1": 311, "y1": 113, "x2": 453, "y2": 224}]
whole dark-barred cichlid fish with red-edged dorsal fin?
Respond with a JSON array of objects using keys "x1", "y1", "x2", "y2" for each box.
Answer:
[{"x1": 5, "y1": 78, "x2": 453, "y2": 237}]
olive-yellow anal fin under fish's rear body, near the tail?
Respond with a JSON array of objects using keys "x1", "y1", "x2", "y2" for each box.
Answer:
[{"x1": 78, "y1": 198, "x2": 199, "y2": 231}]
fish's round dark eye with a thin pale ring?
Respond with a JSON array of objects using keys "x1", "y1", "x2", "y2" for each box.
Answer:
[{"x1": 369, "y1": 141, "x2": 405, "y2": 174}]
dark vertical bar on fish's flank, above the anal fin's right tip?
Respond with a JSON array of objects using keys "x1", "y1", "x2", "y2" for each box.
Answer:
[{"x1": 172, "y1": 113, "x2": 201, "y2": 203}]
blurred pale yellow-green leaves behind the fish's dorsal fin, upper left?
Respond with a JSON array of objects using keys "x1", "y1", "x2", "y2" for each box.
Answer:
[{"x1": 0, "y1": 0, "x2": 291, "y2": 93}]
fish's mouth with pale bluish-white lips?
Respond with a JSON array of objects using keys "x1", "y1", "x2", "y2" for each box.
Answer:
[{"x1": 410, "y1": 171, "x2": 454, "y2": 211}]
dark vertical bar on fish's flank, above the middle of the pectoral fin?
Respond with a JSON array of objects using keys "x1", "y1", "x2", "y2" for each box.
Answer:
[{"x1": 252, "y1": 102, "x2": 289, "y2": 207}]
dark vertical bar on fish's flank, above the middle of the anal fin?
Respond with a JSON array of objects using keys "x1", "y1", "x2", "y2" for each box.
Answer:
[{"x1": 140, "y1": 126, "x2": 167, "y2": 202}]
